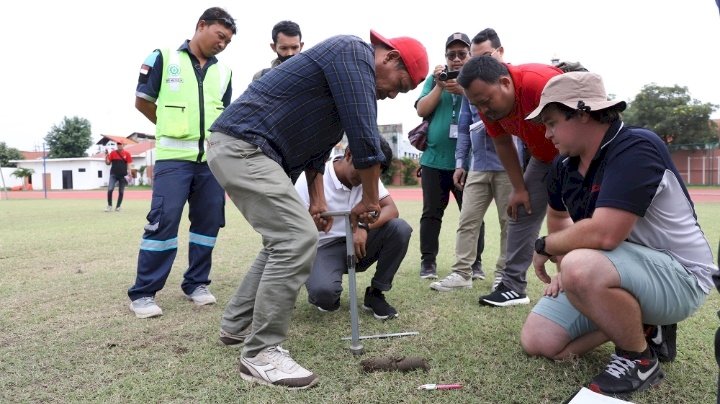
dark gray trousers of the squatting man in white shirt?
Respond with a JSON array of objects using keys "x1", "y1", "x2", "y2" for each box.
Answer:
[{"x1": 305, "y1": 218, "x2": 412, "y2": 310}]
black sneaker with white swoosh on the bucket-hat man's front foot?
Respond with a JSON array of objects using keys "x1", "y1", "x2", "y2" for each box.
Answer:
[{"x1": 588, "y1": 348, "x2": 665, "y2": 396}]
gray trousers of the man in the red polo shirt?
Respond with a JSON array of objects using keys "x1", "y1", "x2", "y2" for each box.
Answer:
[{"x1": 503, "y1": 157, "x2": 550, "y2": 293}]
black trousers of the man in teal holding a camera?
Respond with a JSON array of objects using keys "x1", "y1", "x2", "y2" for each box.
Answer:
[{"x1": 420, "y1": 166, "x2": 485, "y2": 262}]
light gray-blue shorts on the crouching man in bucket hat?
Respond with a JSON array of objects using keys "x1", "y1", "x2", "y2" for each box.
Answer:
[{"x1": 532, "y1": 242, "x2": 707, "y2": 339}]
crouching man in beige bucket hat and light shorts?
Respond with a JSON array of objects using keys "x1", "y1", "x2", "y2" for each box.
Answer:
[{"x1": 521, "y1": 72, "x2": 718, "y2": 396}]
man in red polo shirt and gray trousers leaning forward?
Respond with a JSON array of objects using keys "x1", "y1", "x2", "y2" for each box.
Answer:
[{"x1": 458, "y1": 56, "x2": 562, "y2": 307}]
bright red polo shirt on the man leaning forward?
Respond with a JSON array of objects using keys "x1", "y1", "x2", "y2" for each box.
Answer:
[{"x1": 480, "y1": 63, "x2": 562, "y2": 163}]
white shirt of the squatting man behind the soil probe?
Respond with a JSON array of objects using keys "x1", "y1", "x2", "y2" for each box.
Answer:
[{"x1": 295, "y1": 161, "x2": 390, "y2": 246}]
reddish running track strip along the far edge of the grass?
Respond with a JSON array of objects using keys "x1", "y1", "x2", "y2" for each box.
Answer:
[{"x1": 0, "y1": 187, "x2": 720, "y2": 202}]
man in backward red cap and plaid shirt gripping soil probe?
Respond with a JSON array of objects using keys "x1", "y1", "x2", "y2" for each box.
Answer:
[{"x1": 208, "y1": 31, "x2": 428, "y2": 389}]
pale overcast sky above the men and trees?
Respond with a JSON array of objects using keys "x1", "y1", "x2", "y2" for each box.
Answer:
[{"x1": 0, "y1": 0, "x2": 720, "y2": 150}]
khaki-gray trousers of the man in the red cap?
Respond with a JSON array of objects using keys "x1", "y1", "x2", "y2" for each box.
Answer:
[{"x1": 202, "y1": 133, "x2": 318, "y2": 358}]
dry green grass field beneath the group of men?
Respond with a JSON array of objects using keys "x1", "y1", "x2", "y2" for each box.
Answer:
[{"x1": 0, "y1": 200, "x2": 720, "y2": 403}]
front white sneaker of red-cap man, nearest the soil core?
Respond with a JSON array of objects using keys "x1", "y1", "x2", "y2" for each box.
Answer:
[{"x1": 240, "y1": 345, "x2": 318, "y2": 390}]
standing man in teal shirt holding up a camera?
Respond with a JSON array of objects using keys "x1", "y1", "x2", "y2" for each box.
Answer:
[{"x1": 415, "y1": 32, "x2": 484, "y2": 279}]
